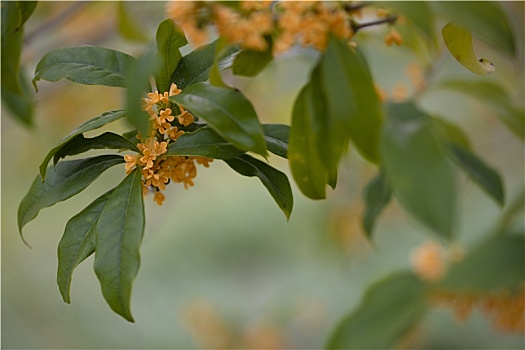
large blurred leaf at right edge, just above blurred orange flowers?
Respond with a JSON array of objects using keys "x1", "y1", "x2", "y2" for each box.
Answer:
[{"x1": 438, "y1": 235, "x2": 525, "y2": 293}]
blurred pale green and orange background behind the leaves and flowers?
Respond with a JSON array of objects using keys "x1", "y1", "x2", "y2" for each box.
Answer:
[{"x1": 1, "y1": 2, "x2": 524, "y2": 349}]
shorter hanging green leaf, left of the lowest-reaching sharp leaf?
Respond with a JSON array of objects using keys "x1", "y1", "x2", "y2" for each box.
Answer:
[{"x1": 57, "y1": 190, "x2": 113, "y2": 304}]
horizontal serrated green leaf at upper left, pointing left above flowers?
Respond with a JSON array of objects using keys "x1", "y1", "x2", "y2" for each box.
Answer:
[{"x1": 33, "y1": 46, "x2": 136, "y2": 88}]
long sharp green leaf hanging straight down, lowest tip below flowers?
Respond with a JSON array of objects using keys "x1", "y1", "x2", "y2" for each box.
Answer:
[{"x1": 94, "y1": 169, "x2": 145, "y2": 322}]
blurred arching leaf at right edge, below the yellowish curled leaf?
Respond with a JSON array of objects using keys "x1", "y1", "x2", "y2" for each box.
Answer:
[{"x1": 435, "y1": 79, "x2": 525, "y2": 139}]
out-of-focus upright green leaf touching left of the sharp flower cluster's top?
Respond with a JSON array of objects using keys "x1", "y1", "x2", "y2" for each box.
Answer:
[{"x1": 126, "y1": 52, "x2": 159, "y2": 135}]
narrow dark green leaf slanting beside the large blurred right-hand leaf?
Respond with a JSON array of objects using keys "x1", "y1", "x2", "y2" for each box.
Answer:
[{"x1": 447, "y1": 144, "x2": 505, "y2": 205}]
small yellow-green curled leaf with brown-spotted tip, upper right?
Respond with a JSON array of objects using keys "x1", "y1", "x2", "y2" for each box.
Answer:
[{"x1": 441, "y1": 22, "x2": 496, "y2": 75}]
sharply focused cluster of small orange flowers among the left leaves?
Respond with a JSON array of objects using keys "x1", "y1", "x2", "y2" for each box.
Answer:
[{"x1": 124, "y1": 84, "x2": 212, "y2": 205}]
